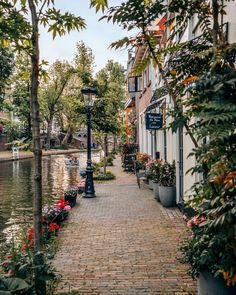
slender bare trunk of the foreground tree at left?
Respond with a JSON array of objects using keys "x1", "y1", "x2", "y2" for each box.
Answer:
[{"x1": 28, "y1": 0, "x2": 46, "y2": 295}]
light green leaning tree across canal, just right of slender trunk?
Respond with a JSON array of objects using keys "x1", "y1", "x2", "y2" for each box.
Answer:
[{"x1": 40, "y1": 61, "x2": 74, "y2": 149}]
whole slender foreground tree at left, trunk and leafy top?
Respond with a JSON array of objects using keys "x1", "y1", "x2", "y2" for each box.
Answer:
[{"x1": 0, "y1": 0, "x2": 85, "y2": 294}]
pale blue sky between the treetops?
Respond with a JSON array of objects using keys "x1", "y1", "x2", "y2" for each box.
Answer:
[{"x1": 40, "y1": 0, "x2": 128, "y2": 72}]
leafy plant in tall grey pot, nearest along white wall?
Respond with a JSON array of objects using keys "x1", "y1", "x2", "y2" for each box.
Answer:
[{"x1": 159, "y1": 161, "x2": 176, "y2": 207}]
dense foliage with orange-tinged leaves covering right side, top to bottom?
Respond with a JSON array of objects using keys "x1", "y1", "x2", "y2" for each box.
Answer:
[{"x1": 93, "y1": 0, "x2": 236, "y2": 285}]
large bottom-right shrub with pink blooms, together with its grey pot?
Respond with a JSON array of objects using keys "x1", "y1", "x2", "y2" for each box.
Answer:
[{"x1": 180, "y1": 211, "x2": 236, "y2": 295}]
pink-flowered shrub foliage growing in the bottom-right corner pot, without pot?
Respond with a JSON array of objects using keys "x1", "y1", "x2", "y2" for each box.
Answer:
[{"x1": 180, "y1": 215, "x2": 236, "y2": 286}]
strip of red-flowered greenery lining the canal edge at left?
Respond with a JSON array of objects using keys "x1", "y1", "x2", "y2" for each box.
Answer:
[{"x1": 0, "y1": 186, "x2": 84, "y2": 294}]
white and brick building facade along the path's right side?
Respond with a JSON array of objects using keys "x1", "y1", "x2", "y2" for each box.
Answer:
[{"x1": 124, "y1": 2, "x2": 236, "y2": 203}]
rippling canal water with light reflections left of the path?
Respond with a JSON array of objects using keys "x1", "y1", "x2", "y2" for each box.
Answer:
[{"x1": 0, "y1": 153, "x2": 99, "y2": 244}]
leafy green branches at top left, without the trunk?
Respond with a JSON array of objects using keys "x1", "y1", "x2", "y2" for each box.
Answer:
[{"x1": 0, "y1": 0, "x2": 86, "y2": 52}]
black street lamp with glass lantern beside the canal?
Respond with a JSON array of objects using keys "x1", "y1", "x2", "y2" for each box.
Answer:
[{"x1": 81, "y1": 87, "x2": 97, "y2": 198}]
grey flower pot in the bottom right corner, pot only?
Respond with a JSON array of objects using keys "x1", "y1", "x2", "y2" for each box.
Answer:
[{"x1": 198, "y1": 271, "x2": 236, "y2": 295}]
